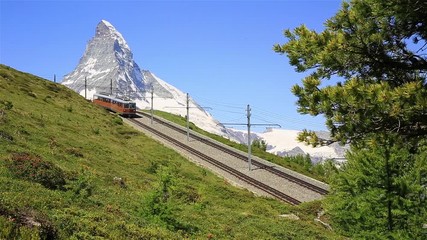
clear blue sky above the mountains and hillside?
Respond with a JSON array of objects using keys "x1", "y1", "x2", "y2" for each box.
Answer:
[{"x1": 0, "y1": 0, "x2": 341, "y2": 131}]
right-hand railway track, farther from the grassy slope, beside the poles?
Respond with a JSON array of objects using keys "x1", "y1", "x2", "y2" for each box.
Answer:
[{"x1": 138, "y1": 112, "x2": 329, "y2": 195}]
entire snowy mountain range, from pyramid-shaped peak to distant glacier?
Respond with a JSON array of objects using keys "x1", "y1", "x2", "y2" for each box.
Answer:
[{"x1": 62, "y1": 20, "x2": 345, "y2": 163}]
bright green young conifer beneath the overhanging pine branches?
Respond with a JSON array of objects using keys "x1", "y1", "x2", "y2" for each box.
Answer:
[{"x1": 326, "y1": 134, "x2": 427, "y2": 239}]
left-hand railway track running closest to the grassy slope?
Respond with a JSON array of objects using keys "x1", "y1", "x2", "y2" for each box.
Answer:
[{"x1": 128, "y1": 118, "x2": 301, "y2": 205}]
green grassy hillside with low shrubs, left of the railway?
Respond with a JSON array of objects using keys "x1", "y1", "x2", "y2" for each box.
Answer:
[{"x1": 0, "y1": 65, "x2": 340, "y2": 239}]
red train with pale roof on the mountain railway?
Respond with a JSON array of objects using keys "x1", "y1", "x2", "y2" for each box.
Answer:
[{"x1": 93, "y1": 93, "x2": 136, "y2": 117}]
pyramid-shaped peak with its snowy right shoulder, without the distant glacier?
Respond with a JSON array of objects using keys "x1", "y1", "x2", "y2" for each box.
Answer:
[{"x1": 62, "y1": 20, "x2": 228, "y2": 136}]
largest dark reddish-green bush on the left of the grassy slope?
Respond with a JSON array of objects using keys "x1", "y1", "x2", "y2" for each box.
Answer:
[{"x1": 6, "y1": 153, "x2": 66, "y2": 189}]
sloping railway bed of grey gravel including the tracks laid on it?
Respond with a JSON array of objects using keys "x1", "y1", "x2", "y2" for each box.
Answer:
[{"x1": 125, "y1": 114, "x2": 329, "y2": 202}]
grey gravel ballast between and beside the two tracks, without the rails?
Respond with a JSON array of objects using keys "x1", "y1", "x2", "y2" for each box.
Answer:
[{"x1": 124, "y1": 116, "x2": 329, "y2": 202}]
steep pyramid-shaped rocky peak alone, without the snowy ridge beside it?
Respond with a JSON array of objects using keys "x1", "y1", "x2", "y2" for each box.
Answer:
[{"x1": 62, "y1": 20, "x2": 146, "y2": 99}]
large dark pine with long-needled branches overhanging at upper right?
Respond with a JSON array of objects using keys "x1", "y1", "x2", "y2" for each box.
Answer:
[{"x1": 274, "y1": 0, "x2": 427, "y2": 145}]
